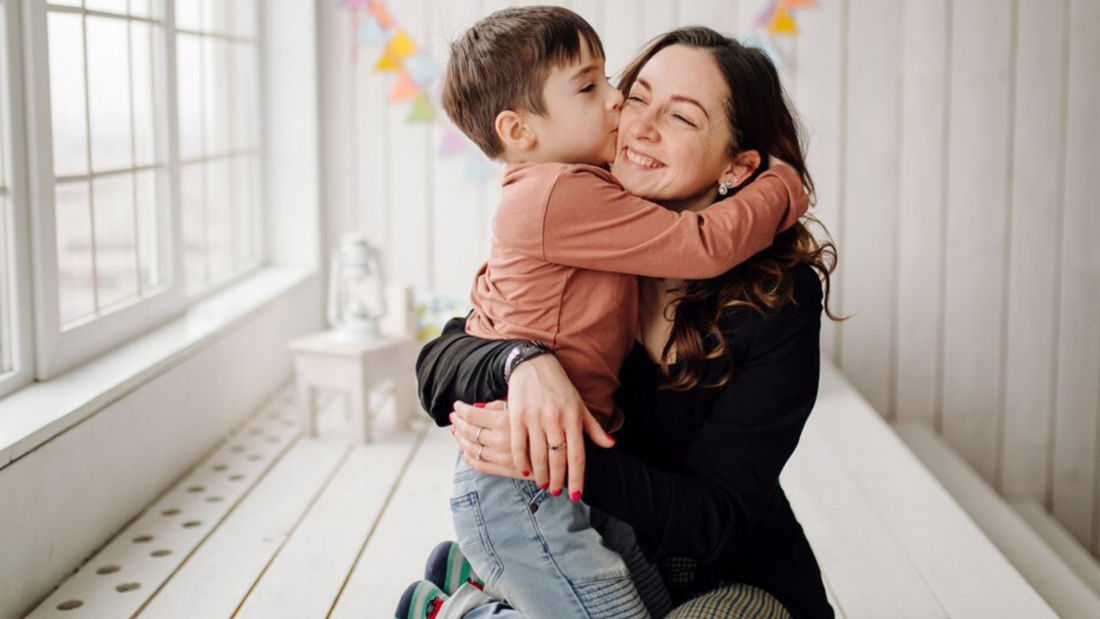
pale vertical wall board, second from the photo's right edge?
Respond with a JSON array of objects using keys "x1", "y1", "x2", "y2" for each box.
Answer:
[{"x1": 1001, "y1": 0, "x2": 1067, "y2": 500}]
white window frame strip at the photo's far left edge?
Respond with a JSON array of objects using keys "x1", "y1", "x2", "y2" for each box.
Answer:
[{"x1": 0, "y1": 0, "x2": 34, "y2": 398}]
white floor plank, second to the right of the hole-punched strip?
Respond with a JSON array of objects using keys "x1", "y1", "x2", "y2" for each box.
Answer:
[{"x1": 234, "y1": 430, "x2": 422, "y2": 619}]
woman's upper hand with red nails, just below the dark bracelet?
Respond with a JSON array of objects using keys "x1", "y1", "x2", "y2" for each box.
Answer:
[{"x1": 508, "y1": 355, "x2": 615, "y2": 500}]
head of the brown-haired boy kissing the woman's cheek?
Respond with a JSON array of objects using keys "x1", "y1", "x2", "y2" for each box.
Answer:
[{"x1": 442, "y1": 7, "x2": 622, "y2": 165}]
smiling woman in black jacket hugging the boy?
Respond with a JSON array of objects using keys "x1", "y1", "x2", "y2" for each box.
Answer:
[{"x1": 417, "y1": 27, "x2": 835, "y2": 618}]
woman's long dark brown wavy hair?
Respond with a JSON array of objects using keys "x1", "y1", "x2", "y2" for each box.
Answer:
[{"x1": 619, "y1": 26, "x2": 843, "y2": 391}]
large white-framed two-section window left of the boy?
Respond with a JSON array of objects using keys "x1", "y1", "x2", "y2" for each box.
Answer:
[{"x1": 25, "y1": 0, "x2": 261, "y2": 378}]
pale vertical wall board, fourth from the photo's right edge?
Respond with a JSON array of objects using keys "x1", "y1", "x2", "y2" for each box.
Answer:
[{"x1": 893, "y1": 0, "x2": 950, "y2": 427}]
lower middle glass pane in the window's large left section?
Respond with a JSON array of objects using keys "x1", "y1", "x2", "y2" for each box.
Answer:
[{"x1": 92, "y1": 174, "x2": 138, "y2": 309}]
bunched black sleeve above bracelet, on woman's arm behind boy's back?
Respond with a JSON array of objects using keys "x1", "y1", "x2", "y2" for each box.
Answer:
[{"x1": 416, "y1": 318, "x2": 517, "y2": 428}]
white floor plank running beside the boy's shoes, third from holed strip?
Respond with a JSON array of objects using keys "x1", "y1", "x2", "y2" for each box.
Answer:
[{"x1": 331, "y1": 427, "x2": 458, "y2": 619}]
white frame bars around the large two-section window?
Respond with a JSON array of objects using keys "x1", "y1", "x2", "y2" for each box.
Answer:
[{"x1": 20, "y1": 0, "x2": 267, "y2": 380}]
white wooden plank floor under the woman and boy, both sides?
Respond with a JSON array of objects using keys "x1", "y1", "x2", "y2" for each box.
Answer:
[{"x1": 29, "y1": 366, "x2": 1055, "y2": 619}]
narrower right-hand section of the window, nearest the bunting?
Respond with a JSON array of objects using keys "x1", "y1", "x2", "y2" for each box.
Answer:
[{"x1": 176, "y1": 0, "x2": 261, "y2": 294}]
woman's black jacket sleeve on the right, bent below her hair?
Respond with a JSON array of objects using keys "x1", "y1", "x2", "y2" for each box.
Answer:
[{"x1": 584, "y1": 269, "x2": 821, "y2": 563}]
